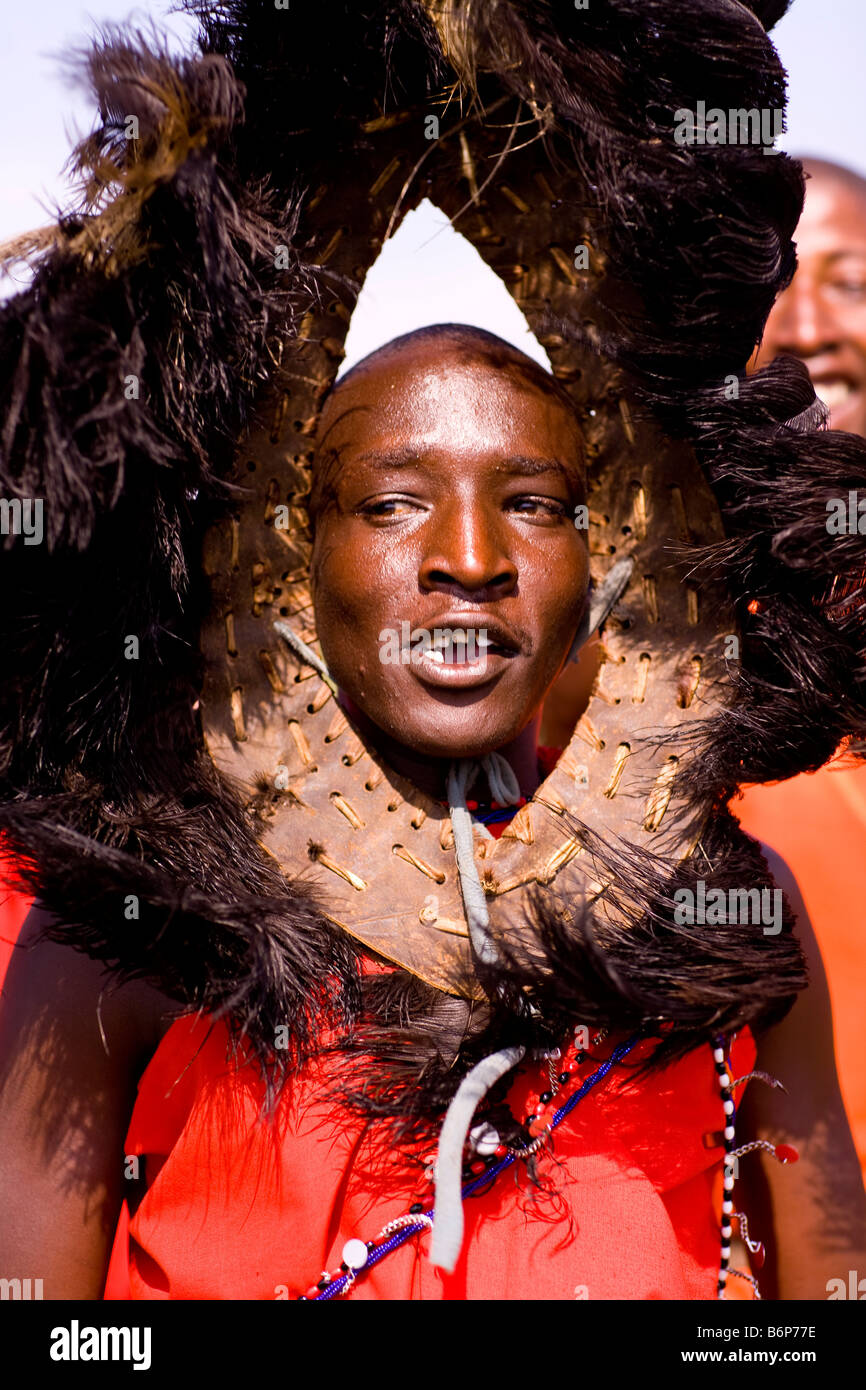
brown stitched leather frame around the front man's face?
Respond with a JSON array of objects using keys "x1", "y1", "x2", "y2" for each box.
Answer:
[{"x1": 202, "y1": 99, "x2": 737, "y2": 994}]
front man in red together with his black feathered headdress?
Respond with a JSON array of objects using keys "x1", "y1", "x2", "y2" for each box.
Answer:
[{"x1": 0, "y1": 0, "x2": 866, "y2": 1298}]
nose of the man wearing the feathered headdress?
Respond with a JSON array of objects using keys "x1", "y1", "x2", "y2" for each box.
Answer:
[{"x1": 418, "y1": 498, "x2": 517, "y2": 599}]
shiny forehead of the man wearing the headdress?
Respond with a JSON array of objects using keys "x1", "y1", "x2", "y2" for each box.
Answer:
[{"x1": 318, "y1": 341, "x2": 581, "y2": 448}]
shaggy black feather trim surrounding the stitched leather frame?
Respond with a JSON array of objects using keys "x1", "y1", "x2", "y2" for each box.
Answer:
[{"x1": 0, "y1": 0, "x2": 866, "y2": 1127}]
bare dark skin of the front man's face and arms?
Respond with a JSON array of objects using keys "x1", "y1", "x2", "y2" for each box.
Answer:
[{"x1": 0, "y1": 333, "x2": 866, "y2": 1300}]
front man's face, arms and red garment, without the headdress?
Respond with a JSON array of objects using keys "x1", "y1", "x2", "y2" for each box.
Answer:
[{"x1": 0, "y1": 328, "x2": 865, "y2": 1298}]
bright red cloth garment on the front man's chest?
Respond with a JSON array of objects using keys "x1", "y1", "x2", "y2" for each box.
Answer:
[{"x1": 126, "y1": 1017, "x2": 755, "y2": 1300}]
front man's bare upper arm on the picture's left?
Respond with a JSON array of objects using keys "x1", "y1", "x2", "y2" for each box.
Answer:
[{"x1": 0, "y1": 905, "x2": 180, "y2": 1298}]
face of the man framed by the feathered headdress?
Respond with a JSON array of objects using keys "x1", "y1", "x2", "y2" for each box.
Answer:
[{"x1": 313, "y1": 339, "x2": 589, "y2": 758}]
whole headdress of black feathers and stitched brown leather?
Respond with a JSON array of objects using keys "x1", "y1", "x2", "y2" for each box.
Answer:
[{"x1": 0, "y1": 0, "x2": 866, "y2": 1115}]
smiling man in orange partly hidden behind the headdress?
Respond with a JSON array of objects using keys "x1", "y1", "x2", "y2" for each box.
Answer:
[{"x1": 734, "y1": 160, "x2": 866, "y2": 1173}]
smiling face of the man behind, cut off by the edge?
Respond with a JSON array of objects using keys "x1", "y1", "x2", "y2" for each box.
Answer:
[{"x1": 755, "y1": 172, "x2": 866, "y2": 435}]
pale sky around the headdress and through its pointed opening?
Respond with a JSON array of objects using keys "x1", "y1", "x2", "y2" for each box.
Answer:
[{"x1": 0, "y1": 0, "x2": 866, "y2": 330}]
